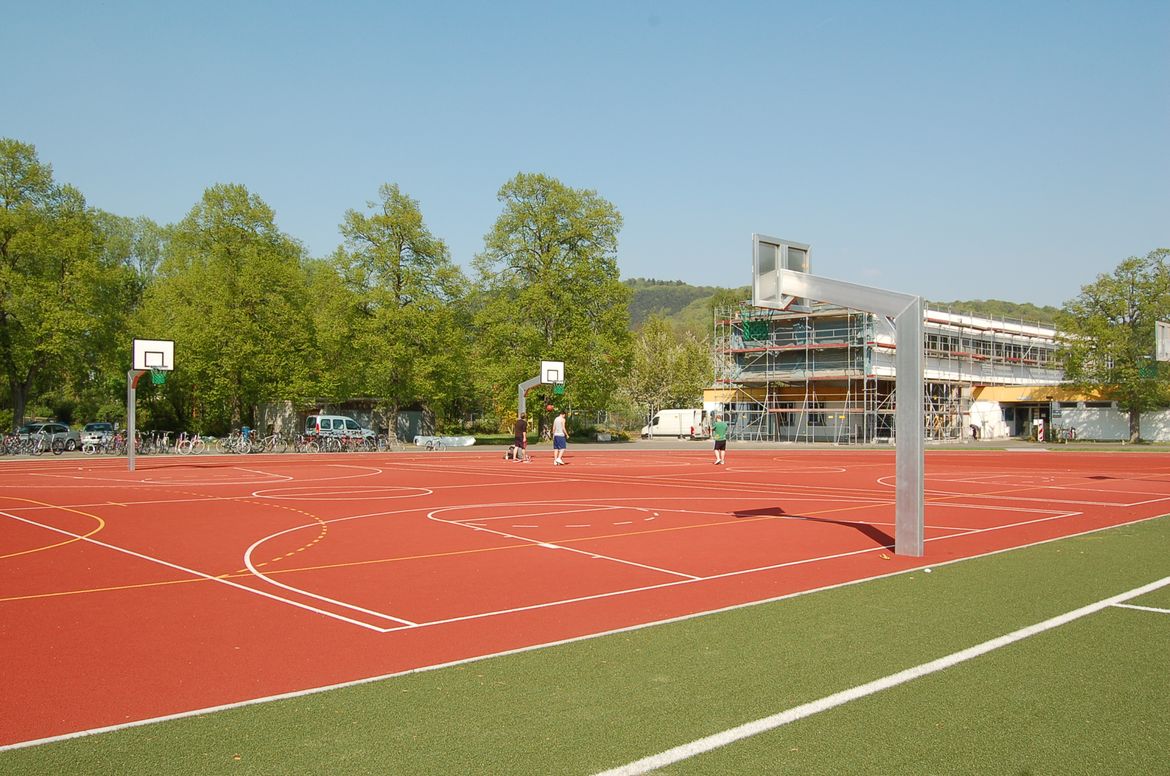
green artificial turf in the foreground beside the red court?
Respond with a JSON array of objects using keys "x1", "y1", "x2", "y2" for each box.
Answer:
[{"x1": 0, "y1": 517, "x2": 1170, "y2": 776}]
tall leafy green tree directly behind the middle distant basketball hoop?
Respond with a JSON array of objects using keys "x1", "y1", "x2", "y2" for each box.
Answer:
[{"x1": 474, "y1": 173, "x2": 629, "y2": 426}]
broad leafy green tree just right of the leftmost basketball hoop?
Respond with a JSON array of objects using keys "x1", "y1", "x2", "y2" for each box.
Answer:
[{"x1": 139, "y1": 185, "x2": 318, "y2": 430}]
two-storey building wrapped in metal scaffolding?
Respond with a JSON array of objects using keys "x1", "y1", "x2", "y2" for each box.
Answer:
[{"x1": 704, "y1": 304, "x2": 1061, "y2": 444}]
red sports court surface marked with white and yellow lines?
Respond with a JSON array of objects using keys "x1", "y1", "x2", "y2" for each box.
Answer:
[{"x1": 0, "y1": 448, "x2": 1170, "y2": 746}]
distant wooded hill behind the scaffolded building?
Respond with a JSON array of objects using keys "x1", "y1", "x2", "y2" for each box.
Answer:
[{"x1": 622, "y1": 277, "x2": 1060, "y2": 335}]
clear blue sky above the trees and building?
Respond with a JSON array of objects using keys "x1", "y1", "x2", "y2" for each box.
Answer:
[{"x1": 0, "y1": 0, "x2": 1170, "y2": 305}]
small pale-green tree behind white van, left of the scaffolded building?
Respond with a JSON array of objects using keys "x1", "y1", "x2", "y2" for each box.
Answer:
[{"x1": 622, "y1": 315, "x2": 711, "y2": 428}]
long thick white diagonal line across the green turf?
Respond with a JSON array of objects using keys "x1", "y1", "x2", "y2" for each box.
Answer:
[{"x1": 597, "y1": 577, "x2": 1170, "y2": 776}]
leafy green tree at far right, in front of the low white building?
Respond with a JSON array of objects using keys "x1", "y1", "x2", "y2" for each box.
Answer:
[{"x1": 1058, "y1": 248, "x2": 1170, "y2": 441}]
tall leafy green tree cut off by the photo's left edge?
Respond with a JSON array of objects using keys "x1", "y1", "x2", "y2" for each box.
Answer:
[{"x1": 0, "y1": 138, "x2": 125, "y2": 425}]
